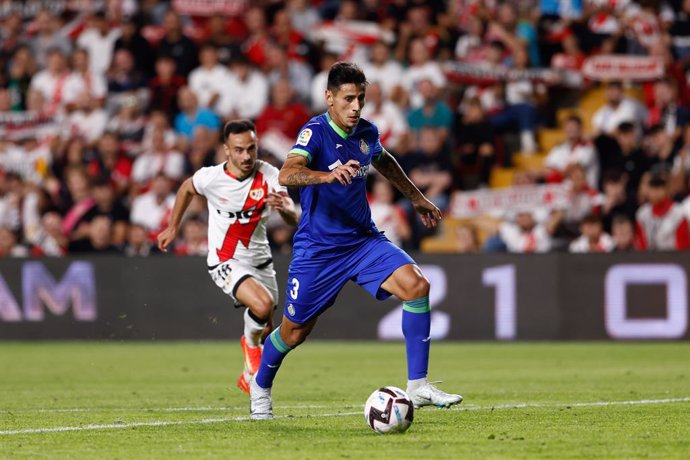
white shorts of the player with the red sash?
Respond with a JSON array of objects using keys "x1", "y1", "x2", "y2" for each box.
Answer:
[{"x1": 208, "y1": 259, "x2": 278, "y2": 308}]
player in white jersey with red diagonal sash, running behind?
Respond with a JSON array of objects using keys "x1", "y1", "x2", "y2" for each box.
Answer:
[{"x1": 158, "y1": 120, "x2": 297, "y2": 393}]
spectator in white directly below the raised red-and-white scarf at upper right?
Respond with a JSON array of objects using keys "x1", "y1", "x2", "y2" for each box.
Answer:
[{"x1": 592, "y1": 81, "x2": 646, "y2": 137}]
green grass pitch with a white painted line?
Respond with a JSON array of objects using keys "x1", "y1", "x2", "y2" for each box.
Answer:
[{"x1": 0, "y1": 341, "x2": 690, "y2": 459}]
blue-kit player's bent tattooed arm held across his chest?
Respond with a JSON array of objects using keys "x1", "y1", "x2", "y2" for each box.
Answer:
[{"x1": 278, "y1": 154, "x2": 359, "y2": 187}]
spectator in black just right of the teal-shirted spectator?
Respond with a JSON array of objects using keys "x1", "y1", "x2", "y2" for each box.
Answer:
[{"x1": 454, "y1": 98, "x2": 496, "y2": 189}]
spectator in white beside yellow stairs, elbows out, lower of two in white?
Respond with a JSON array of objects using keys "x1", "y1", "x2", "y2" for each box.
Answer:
[{"x1": 544, "y1": 115, "x2": 599, "y2": 188}]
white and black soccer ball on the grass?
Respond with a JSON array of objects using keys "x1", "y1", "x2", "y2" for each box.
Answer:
[{"x1": 364, "y1": 387, "x2": 414, "y2": 434}]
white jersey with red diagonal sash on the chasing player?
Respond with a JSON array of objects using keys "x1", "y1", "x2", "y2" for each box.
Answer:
[{"x1": 192, "y1": 160, "x2": 287, "y2": 267}]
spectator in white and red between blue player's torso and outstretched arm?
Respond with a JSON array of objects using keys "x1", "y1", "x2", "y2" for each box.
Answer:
[{"x1": 369, "y1": 179, "x2": 412, "y2": 247}]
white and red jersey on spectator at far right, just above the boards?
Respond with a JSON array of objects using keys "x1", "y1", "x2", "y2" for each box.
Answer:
[{"x1": 635, "y1": 199, "x2": 690, "y2": 251}]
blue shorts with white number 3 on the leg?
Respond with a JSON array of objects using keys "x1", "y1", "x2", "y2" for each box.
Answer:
[{"x1": 283, "y1": 234, "x2": 415, "y2": 324}]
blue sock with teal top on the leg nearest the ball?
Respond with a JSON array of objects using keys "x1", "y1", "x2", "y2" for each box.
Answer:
[{"x1": 403, "y1": 296, "x2": 431, "y2": 380}]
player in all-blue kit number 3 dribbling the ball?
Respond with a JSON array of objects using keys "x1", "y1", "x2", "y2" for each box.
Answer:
[{"x1": 249, "y1": 62, "x2": 462, "y2": 420}]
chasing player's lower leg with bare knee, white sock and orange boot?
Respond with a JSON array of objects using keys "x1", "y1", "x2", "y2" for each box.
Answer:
[{"x1": 234, "y1": 276, "x2": 275, "y2": 393}]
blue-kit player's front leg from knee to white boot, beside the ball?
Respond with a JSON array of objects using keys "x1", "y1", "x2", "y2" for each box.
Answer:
[{"x1": 381, "y1": 264, "x2": 462, "y2": 407}]
